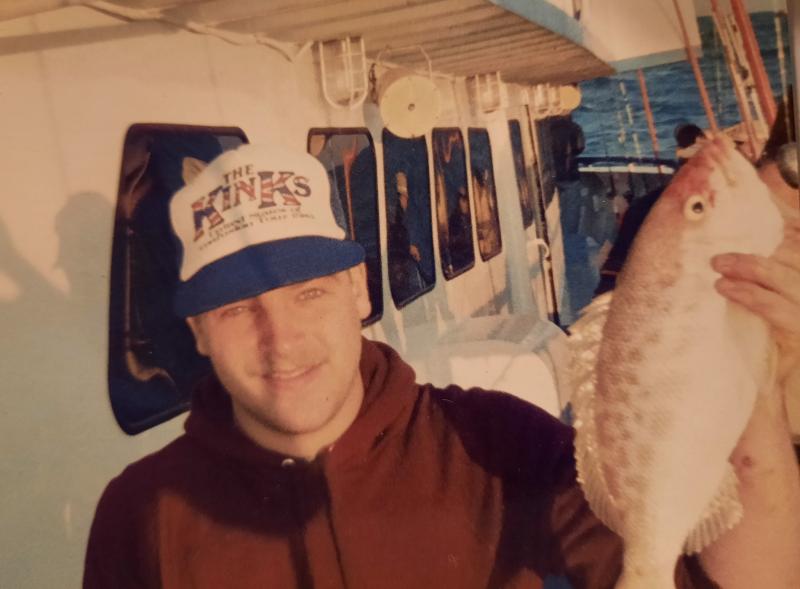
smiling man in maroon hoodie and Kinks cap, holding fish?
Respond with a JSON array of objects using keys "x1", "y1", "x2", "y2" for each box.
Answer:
[{"x1": 84, "y1": 146, "x2": 800, "y2": 589}]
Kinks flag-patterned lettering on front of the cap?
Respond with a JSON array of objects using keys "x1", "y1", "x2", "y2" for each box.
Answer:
[{"x1": 192, "y1": 164, "x2": 311, "y2": 241}]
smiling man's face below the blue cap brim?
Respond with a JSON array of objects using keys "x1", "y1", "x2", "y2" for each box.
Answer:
[{"x1": 188, "y1": 264, "x2": 370, "y2": 451}]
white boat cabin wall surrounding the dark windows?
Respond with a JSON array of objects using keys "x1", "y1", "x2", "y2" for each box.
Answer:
[{"x1": 0, "y1": 0, "x2": 712, "y2": 588}]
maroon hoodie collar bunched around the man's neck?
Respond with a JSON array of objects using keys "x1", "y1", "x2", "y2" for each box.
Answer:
[{"x1": 185, "y1": 338, "x2": 416, "y2": 468}]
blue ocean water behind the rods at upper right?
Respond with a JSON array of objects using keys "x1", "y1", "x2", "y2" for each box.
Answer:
[{"x1": 572, "y1": 12, "x2": 793, "y2": 158}]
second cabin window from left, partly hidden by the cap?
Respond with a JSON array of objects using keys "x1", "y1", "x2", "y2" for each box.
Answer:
[{"x1": 308, "y1": 129, "x2": 383, "y2": 325}]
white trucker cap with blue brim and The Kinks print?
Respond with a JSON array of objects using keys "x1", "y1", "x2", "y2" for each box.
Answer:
[{"x1": 170, "y1": 144, "x2": 364, "y2": 317}]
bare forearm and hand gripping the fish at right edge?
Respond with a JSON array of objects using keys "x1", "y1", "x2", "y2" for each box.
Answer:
[{"x1": 700, "y1": 221, "x2": 800, "y2": 589}]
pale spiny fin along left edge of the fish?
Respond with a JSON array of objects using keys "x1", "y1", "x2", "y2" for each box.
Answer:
[{"x1": 569, "y1": 292, "x2": 620, "y2": 533}]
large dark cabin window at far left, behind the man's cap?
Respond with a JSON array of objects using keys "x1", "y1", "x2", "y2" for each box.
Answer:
[{"x1": 108, "y1": 125, "x2": 247, "y2": 434}]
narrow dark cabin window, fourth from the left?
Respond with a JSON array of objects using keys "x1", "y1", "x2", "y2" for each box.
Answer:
[{"x1": 433, "y1": 129, "x2": 475, "y2": 280}]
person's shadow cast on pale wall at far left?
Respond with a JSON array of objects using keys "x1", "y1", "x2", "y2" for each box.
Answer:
[{"x1": 0, "y1": 192, "x2": 126, "y2": 587}]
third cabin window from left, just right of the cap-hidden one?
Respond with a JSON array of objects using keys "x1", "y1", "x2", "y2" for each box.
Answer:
[{"x1": 383, "y1": 129, "x2": 436, "y2": 308}]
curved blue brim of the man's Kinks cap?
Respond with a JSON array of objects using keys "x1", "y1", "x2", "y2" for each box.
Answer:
[{"x1": 174, "y1": 236, "x2": 364, "y2": 317}]
